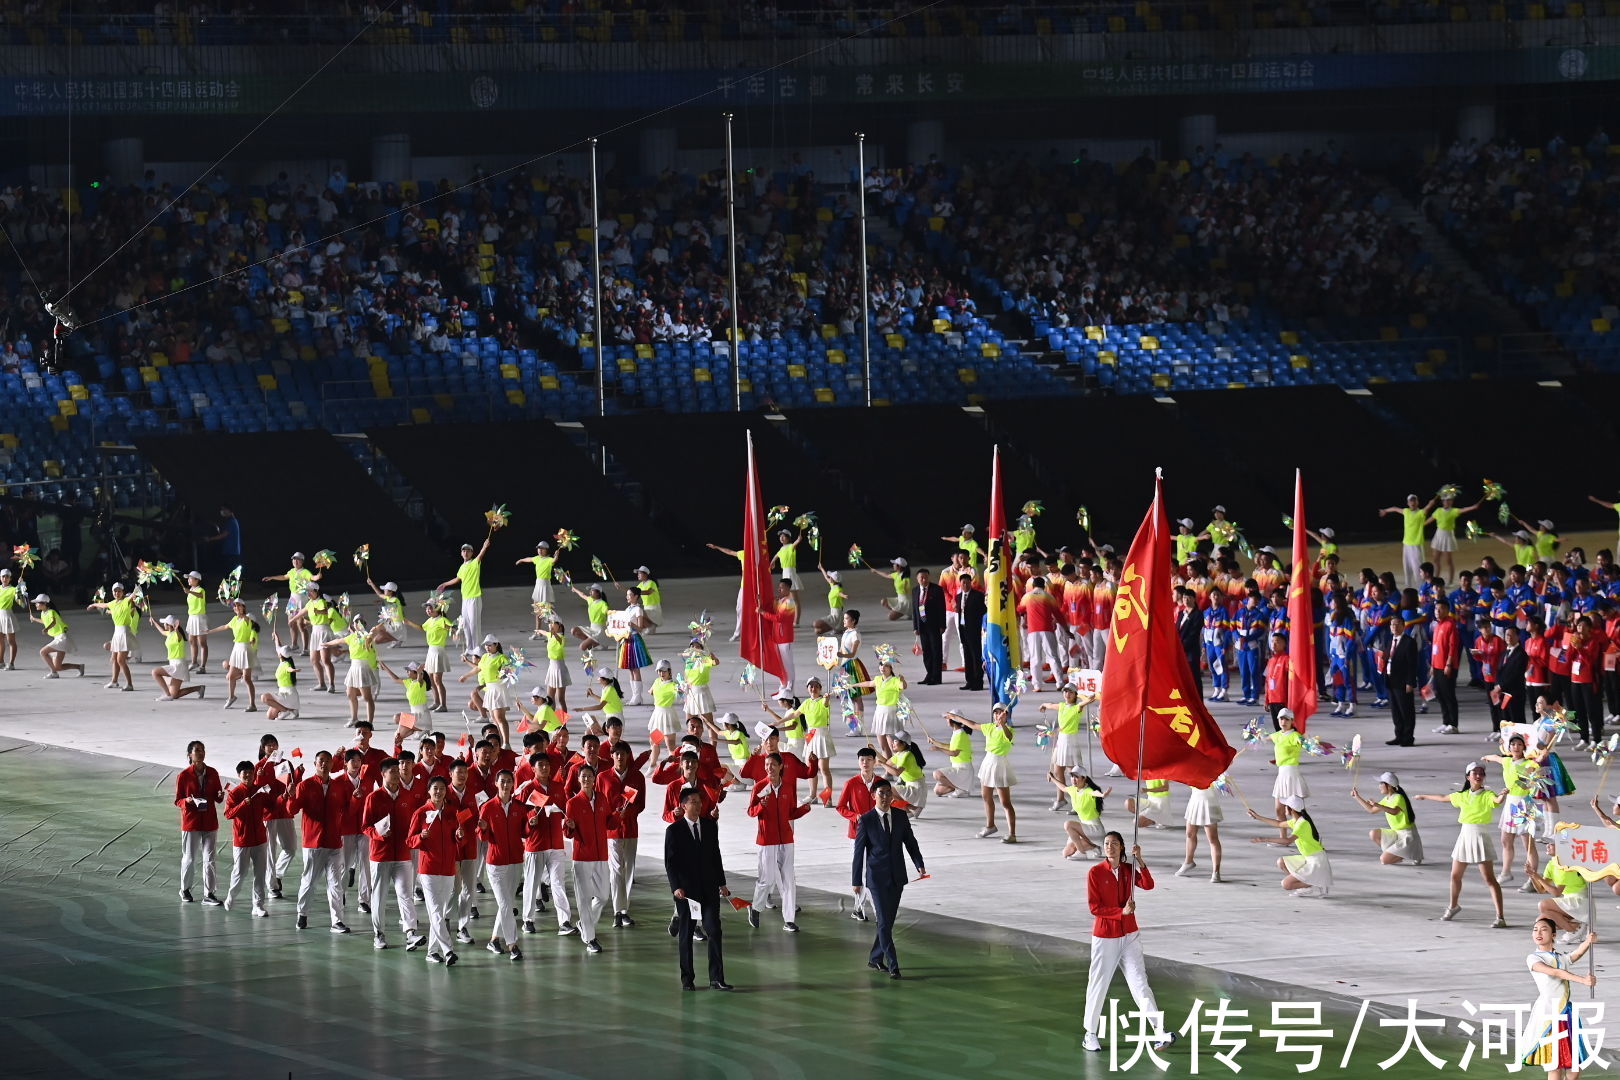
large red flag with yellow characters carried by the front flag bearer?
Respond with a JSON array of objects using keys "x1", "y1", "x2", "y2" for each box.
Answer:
[{"x1": 1100, "y1": 476, "x2": 1238, "y2": 787}]
